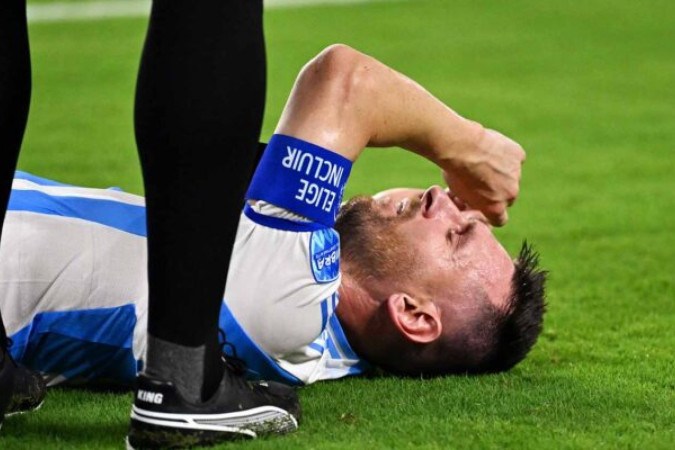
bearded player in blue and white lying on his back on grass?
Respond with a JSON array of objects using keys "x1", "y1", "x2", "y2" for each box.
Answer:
[{"x1": 0, "y1": 45, "x2": 545, "y2": 388}]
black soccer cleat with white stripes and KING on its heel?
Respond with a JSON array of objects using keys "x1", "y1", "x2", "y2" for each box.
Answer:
[{"x1": 127, "y1": 368, "x2": 300, "y2": 450}]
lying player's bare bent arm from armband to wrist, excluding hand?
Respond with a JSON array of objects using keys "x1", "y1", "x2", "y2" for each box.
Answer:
[{"x1": 276, "y1": 42, "x2": 483, "y2": 163}]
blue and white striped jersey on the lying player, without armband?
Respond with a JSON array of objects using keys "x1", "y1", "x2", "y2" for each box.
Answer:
[{"x1": 0, "y1": 172, "x2": 367, "y2": 385}]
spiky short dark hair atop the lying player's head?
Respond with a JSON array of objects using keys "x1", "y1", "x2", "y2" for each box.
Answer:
[{"x1": 468, "y1": 241, "x2": 548, "y2": 374}]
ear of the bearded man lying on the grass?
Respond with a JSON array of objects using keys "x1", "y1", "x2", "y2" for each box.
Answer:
[{"x1": 387, "y1": 293, "x2": 443, "y2": 344}]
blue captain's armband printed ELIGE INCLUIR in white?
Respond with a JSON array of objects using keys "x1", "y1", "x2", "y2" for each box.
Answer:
[{"x1": 246, "y1": 134, "x2": 352, "y2": 227}]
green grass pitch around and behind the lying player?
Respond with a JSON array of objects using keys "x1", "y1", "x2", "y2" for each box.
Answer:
[{"x1": 0, "y1": 0, "x2": 675, "y2": 450}]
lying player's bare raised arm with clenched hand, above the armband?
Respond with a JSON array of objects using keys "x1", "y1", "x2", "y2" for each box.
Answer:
[{"x1": 275, "y1": 44, "x2": 525, "y2": 226}]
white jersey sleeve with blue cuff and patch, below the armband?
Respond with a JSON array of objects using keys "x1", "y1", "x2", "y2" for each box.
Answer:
[{"x1": 225, "y1": 202, "x2": 340, "y2": 359}]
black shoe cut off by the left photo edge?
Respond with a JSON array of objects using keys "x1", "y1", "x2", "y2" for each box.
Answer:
[{"x1": 0, "y1": 339, "x2": 47, "y2": 426}]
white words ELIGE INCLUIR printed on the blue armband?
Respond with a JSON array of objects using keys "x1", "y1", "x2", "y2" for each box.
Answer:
[{"x1": 281, "y1": 146, "x2": 344, "y2": 212}]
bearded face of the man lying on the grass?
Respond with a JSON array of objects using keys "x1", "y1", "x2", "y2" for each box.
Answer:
[{"x1": 335, "y1": 186, "x2": 514, "y2": 308}]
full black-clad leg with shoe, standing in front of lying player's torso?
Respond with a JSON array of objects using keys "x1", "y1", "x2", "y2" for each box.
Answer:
[{"x1": 129, "y1": 0, "x2": 297, "y2": 446}]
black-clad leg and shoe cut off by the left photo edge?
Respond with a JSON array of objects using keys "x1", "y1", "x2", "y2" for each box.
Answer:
[{"x1": 0, "y1": 0, "x2": 45, "y2": 425}]
